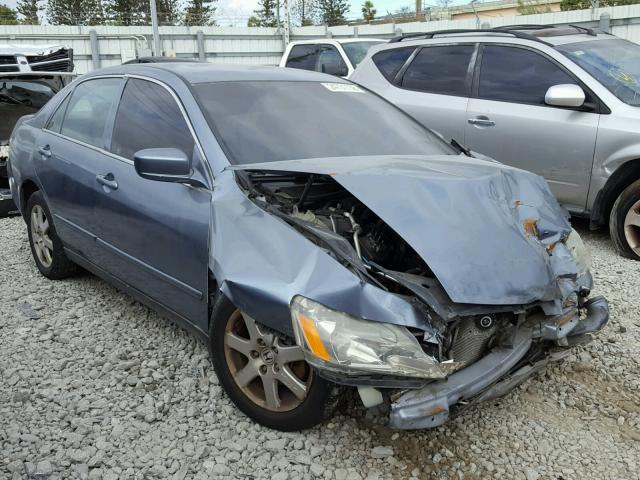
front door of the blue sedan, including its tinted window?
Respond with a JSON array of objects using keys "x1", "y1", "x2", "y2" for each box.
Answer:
[{"x1": 96, "y1": 78, "x2": 211, "y2": 332}]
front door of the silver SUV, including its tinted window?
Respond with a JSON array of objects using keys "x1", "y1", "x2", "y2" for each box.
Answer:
[{"x1": 465, "y1": 44, "x2": 599, "y2": 210}]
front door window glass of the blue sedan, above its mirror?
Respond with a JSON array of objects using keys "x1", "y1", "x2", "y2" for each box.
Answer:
[{"x1": 111, "y1": 79, "x2": 195, "y2": 160}]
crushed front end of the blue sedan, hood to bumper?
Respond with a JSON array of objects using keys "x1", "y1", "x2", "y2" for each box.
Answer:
[{"x1": 219, "y1": 156, "x2": 608, "y2": 429}]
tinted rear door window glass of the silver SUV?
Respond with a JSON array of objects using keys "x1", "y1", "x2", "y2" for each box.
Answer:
[{"x1": 401, "y1": 45, "x2": 475, "y2": 97}]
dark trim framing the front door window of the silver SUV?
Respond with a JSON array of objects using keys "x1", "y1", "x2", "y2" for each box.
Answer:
[{"x1": 470, "y1": 42, "x2": 611, "y2": 115}]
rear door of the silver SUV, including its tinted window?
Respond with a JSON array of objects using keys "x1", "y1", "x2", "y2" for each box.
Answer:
[{"x1": 374, "y1": 44, "x2": 476, "y2": 143}]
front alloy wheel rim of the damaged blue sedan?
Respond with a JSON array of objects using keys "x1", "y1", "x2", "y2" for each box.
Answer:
[{"x1": 224, "y1": 310, "x2": 314, "y2": 412}]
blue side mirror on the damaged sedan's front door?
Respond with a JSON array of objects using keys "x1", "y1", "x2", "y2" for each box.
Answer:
[{"x1": 133, "y1": 148, "x2": 191, "y2": 183}]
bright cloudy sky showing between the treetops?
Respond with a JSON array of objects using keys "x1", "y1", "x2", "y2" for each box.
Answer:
[{"x1": 0, "y1": 0, "x2": 469, "y2": 26}]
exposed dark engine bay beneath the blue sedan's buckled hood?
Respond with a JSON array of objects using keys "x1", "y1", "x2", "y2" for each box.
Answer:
[{"x1": 237, "y1": 171, "x2": 517, "y2": 366}]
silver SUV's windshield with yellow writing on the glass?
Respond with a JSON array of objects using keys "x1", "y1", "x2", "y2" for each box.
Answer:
[{"x1": 556, "y1": 38, "x2": 640, "y2": 106}]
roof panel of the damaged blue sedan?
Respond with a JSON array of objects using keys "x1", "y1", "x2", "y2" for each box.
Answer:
[{"x1": 85, "y1": 62, "x2": 349, "y2": 84}]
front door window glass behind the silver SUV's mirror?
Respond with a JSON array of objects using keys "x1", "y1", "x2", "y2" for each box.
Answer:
[{"x1": 478, "y1": 45, "x2": 576, "y2": 105}]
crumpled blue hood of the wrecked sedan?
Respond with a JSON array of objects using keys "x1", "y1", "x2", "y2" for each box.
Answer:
[{"x1": 230, "y1": 155, "x2": 576, "y2": 305}]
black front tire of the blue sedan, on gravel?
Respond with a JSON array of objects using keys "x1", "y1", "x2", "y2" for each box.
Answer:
[{"x1": 209, "y1": 293, "x2": 339, "y2": 432}]
